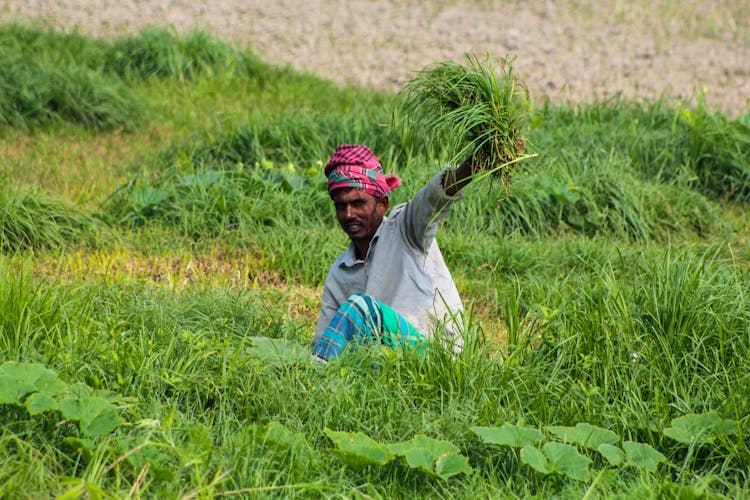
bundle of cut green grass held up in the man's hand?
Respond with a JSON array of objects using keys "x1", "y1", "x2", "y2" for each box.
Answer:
[{"x1": 393, "y1": 55, "x2": 530, "y2": 188}]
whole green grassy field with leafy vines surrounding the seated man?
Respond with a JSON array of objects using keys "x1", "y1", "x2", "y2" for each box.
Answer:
[{"x1": 0, "y1": 25, "x2": 750, "y2": 498}]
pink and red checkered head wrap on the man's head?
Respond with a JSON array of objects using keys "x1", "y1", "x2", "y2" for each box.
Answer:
[{"x1": 325, "y1": 144, "x2": 401, "y2": 198}]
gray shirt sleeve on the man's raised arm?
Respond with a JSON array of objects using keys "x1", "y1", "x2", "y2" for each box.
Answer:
[{"x1": 400, "y1": 168, "x2": 463, "y2": 251}]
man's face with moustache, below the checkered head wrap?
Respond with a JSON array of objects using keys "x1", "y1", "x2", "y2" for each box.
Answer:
[{"x1": 331, "y1": 188, "x2": 388, "y2": 245}]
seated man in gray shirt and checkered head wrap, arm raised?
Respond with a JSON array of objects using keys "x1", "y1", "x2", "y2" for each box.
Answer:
[{"x1": 312, "y1": 144, "x2": 472, "y2": 361}]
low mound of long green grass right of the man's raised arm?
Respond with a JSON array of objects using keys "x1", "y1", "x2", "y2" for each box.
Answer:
[{"x1": 493, "y1": 157, "x2": 720, "y2": 241}]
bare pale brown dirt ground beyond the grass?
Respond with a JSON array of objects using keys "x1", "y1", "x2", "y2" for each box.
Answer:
[{"x1": 0, "y1": 0, "x2": 750, "y2": 116}]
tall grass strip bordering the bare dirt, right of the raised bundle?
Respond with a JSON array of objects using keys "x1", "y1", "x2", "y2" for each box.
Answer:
[{"x1": 533, "y1": 99, "x2": 750, "y2": 203}]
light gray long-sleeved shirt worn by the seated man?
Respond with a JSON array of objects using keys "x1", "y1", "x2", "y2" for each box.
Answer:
[{"x1": 312, "y1": 170, "x2": 463, "y2": 345}]
